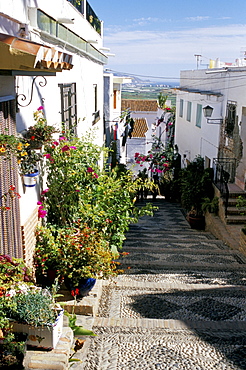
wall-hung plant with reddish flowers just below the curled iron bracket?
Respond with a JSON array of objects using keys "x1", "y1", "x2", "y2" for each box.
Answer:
[{"x1": 22, "y1": 106, "x2": 58, "y2": 149}]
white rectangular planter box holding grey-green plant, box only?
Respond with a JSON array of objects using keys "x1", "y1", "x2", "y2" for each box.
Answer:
[{"x1": 13, "y1": 310, "x2": 64, "y2": 349}]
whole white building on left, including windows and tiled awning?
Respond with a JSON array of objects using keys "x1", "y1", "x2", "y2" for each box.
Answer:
[{"x1": 0, "y1": 0, "x2": 107, "y2": 266}]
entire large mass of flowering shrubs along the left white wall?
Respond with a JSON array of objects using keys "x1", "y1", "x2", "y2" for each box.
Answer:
[{"x1": 35, "y1": 132, "x2": 155, "y2": 283}]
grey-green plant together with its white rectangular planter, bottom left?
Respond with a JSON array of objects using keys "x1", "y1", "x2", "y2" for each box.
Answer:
[{"x1": 2, "y1": 283, "x2": 63, "y2": 349}]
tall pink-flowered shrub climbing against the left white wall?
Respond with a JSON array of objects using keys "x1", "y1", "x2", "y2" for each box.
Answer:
[{"x1": 41, "y1": 136, "x2": 101, "y2": 226}]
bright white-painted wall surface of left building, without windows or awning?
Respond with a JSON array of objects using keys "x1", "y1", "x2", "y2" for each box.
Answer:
[{"x1": 0, "y1": 0, "x2": 107, "y2": 224}]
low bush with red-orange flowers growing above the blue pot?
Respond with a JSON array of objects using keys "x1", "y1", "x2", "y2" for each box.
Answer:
[{"x1": 35, "y1": 221, "x2": 116, "y2": 286}]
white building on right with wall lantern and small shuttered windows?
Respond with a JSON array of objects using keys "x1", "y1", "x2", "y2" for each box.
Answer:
[{"x1": 175, "y1": 63, "x2": 246, "y2": 190}]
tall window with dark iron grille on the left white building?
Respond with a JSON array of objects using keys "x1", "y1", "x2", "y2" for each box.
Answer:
[{"x1": 59, "y1": 83, "x2": 77, "y2": 135}]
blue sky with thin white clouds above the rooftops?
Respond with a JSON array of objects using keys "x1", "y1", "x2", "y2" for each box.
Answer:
[{"x1": 89, "y1": 0, "x2": 246, "y2": 81}]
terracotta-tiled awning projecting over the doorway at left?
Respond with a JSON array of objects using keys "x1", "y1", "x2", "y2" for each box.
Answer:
[{"x1": 0, "y1": 33, "x2": 73, "y2": 73}]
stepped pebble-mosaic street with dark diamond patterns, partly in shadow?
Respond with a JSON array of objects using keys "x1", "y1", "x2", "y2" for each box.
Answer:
[{"x1": 79, "y1": 199, "x2": 246, "y2": 370}]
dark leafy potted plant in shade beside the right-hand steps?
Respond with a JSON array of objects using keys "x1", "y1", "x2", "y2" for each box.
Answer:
[{"x1": 181, "y1": 156, "x2": 214, "y2": 229}]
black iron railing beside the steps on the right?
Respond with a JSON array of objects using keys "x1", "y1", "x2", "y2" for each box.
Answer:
[{"x1": 213, "y1": 158, "x2": 237, "y2": 216}]
